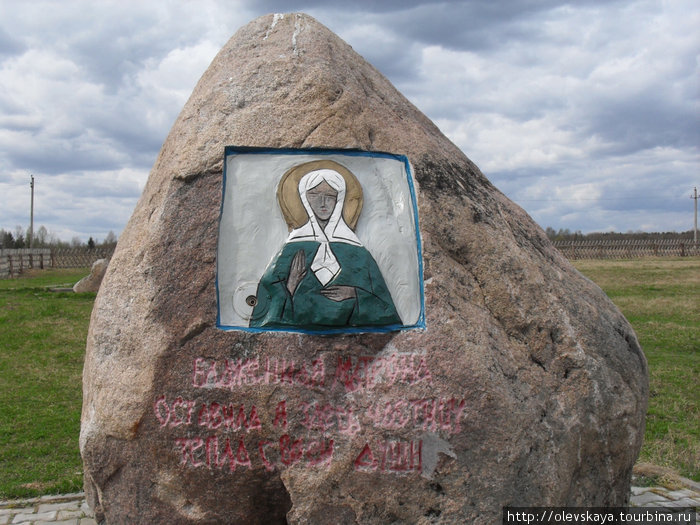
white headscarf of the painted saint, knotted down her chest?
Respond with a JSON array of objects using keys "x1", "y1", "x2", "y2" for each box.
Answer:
[{"x1": 287, "y1": 169, "x2": 362, "y2": 286}]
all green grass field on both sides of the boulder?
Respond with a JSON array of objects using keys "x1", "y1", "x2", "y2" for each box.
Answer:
[{"x1": 0, "y1": 257, "x2": 700, "y2": 499}]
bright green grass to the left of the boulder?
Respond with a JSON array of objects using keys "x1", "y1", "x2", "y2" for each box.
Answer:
[{"x1": 0, "y1": 269, "x2": 95, "y2": 499}]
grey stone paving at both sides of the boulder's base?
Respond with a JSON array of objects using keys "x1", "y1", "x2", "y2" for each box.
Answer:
[{"x1": 0, "y1": 484, "x2": 700, "y2": 525}]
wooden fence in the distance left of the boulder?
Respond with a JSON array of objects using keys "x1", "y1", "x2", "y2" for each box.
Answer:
[{"x1": 0, "y1": 248, "x2": 114, "y2": 278}]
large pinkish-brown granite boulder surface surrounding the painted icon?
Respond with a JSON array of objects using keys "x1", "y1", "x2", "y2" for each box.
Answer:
[{"x1": 80, "y1": 14, "x2": 648, "y2": 524}]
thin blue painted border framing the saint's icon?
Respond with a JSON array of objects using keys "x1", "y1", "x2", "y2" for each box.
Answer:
[{"x1": 216, "y1": 146, "x2": 426, "y2": 335}]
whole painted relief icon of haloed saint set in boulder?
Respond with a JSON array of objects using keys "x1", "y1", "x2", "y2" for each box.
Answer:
[{"x1": 217, "y1": 147, "x2": 425, "y2": 333}]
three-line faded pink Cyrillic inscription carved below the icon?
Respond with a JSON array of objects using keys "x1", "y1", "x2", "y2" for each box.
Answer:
[{"x1": 159, "y1": 350, "x2": 456, "y2": 475}]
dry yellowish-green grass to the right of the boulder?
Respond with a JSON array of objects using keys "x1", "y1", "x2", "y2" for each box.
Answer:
[{"x1": 574, "y1": 257, "x2": 700, "y2": 481}]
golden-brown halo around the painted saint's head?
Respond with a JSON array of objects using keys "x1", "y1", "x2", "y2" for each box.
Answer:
[{"x1": 277, "y1": 159, "x2": 362, "y2": 230}]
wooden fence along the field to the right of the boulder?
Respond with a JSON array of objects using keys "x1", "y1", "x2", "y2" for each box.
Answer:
[{"x1": 554, "y1": 239, "x2": 700, "y2": 259}]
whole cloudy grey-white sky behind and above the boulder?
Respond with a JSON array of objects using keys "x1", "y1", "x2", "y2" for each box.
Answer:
[{"x1": 0, "y1": 0, "x2": 700, "y2": 241}]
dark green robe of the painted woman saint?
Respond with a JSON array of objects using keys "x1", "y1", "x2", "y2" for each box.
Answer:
[{"x1": 250, "y1": 241, "x2": 401, "y2": 330}]
